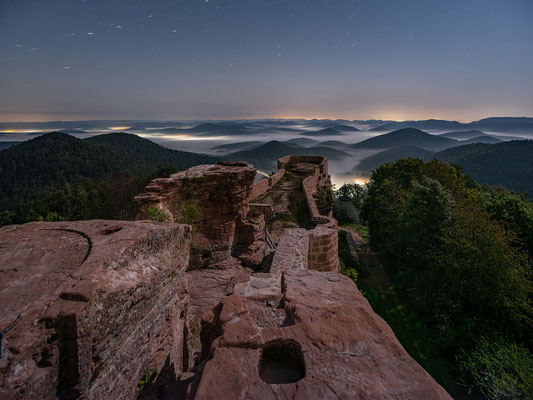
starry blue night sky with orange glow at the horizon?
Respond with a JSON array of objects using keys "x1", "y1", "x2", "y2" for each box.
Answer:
[{"x1": 0, "y1": 0, "x2": 533, "y2": 121}]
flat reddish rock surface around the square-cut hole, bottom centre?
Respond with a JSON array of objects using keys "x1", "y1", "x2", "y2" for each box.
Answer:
[{"x1": 196, "y1": 270, "x2": 450, "y2": 400}]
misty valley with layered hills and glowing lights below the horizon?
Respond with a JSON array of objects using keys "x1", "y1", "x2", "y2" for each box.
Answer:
[{"x1": 0, "y1": 118, "x2": 533, "y2": 187}]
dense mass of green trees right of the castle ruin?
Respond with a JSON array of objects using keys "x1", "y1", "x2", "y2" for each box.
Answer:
[{"x1": 359, "y1": 159, "x2": 533, "y2": 399}]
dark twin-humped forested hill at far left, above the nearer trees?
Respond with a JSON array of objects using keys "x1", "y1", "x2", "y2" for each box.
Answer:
[{"x1": 0, "y1": 132, "x2": 215, "y2": 209}]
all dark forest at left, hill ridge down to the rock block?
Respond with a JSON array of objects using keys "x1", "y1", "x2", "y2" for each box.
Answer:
[{"x1": 0, "y1": 132, "x2": 213, "y2": 226}]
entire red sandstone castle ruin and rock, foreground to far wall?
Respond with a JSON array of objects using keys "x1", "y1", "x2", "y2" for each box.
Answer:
[{"x1": 0, "y1": 156, "x2": 450, "y2": 399}]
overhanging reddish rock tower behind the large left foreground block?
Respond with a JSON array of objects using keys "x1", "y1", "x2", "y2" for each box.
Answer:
[{"x1": 135, "y1": 162, "x2": 258, "y2": 268}]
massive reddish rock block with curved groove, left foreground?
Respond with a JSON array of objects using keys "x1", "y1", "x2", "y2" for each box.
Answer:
[{"x1": 0, "y1": 221, "x2": 191, "y2": 399}]
